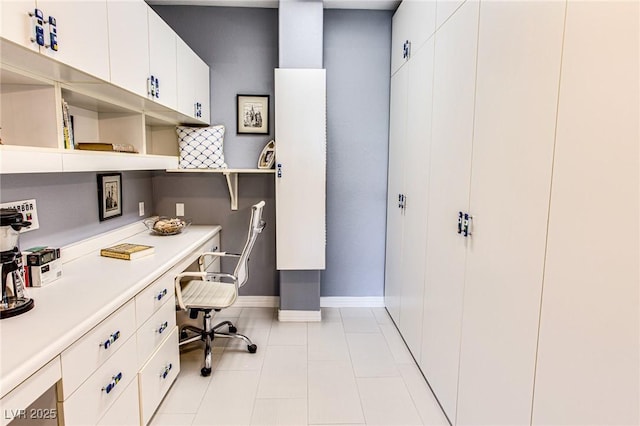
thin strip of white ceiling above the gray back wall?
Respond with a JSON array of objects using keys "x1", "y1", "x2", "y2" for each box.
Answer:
[{"x1": 146, "y1": 0, "x2": 400, "y2": 10}]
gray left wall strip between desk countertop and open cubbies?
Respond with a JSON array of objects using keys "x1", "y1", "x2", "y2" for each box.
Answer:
[{"x1": 0, "y1": 172, "x2": 154, "y2": 249}]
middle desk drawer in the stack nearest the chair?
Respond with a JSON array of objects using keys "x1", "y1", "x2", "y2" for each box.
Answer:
[{"x1": 136, "y1": 294, "x2": 176, "y2": 365}]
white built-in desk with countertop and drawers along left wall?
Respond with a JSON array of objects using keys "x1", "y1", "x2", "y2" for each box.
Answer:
[{"x1": 0, "y1": 223, "x2": 221, "y2": 425}]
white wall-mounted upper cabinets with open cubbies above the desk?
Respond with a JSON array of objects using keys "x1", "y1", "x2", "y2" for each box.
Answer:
[{"x1": 0, "y1": 0, "x2": 210, "y2": 173}]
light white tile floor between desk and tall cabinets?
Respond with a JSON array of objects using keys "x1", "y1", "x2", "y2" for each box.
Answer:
[{"x1": 151, "y1": 308, "x2": 448, "y2": 426}]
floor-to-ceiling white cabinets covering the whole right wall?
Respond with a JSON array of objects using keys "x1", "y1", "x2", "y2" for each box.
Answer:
[{"x1": 385, "y1": 0, "x2": 640, "y2": 425}]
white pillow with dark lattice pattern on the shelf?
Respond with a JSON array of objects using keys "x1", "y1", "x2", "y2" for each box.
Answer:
[{"x1": 176, "y1": 125, "x2": 227, "y2": 169}]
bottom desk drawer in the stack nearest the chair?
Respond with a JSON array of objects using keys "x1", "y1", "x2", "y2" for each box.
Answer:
[{"x1": 138, "y1": 327, "x2": 180, "y2": 425}]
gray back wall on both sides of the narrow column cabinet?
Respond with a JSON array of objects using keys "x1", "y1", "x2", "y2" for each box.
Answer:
[{"x1": 153, "y1": 6, "x2": 392, "y2": 296}]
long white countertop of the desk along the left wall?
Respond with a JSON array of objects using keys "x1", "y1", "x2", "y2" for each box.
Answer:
[{"x1": 0, "y1": 226, "x2": 221, "y2": 397}]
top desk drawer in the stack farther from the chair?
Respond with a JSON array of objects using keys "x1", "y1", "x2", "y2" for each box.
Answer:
[{"x1": 61, "y1": 301, "x2": 136, "y2": 400}]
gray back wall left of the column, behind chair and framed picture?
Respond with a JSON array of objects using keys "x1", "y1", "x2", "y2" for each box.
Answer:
[{"x1": 153, "y1": 6, "x2": 279, "y2": 296}]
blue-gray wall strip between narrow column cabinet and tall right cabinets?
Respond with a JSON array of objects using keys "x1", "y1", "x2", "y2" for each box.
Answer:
[{"x1": 321, "y1": 9, "x2": 392, "y2": 296}]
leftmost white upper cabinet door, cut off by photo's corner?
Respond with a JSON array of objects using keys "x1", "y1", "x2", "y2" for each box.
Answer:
[{"x1": 0, "y1": 0, "x2": 38, "y2": 51}]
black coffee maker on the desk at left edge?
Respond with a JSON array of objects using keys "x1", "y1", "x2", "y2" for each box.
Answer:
[{"x1": 0, "y1": 209, "x2": 34, "y2": 319}]
